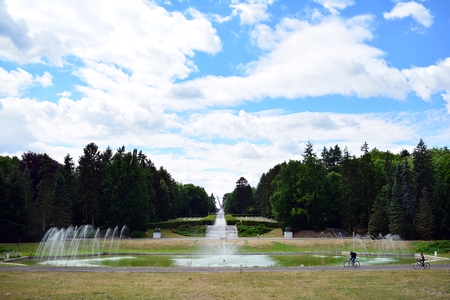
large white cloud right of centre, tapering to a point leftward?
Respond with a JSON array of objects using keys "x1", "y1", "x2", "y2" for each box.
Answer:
[{"x1": 184, "y1": 16, "x2": 416, "y2": 106}]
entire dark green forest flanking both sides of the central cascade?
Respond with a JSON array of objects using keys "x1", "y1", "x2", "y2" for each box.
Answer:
[{"x1": 0, "y1": 140, "x2": 450, "y2": 242}]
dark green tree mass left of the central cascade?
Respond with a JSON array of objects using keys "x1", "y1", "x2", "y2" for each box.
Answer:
[{"x1": 0, "y1": 143, "x2": 215, "y2": 242}]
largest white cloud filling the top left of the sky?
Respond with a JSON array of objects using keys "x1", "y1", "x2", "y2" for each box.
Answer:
[{"x1": 0, "y1": 0, "x2": 221, "y2": 86}]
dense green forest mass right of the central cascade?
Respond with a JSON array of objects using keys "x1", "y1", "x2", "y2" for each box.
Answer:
[{"x1": 224, "y1": 140, "x2": 450, "y2": 240}]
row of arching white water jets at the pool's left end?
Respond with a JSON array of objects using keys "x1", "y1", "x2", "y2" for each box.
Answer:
[{"x1": 35, "y1": 225, "x2": 128, "y2": 265}]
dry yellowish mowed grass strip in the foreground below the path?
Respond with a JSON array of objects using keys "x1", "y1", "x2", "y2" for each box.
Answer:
[{"x1": 0, "y1": 269, "x2": 450, "y2": 299}]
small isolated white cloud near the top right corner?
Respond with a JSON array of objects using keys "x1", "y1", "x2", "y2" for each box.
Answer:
[{"x1": 383, "y1": 1, "x2": 433, "y2": 27}]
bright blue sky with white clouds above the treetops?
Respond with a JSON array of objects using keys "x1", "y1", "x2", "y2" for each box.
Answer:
[{"x1": 0, "y1": 0, "x2": 450, "y2": 197}]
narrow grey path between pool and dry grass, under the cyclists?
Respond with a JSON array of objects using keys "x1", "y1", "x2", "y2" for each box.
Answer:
[{"x1": 0, "y1": 264, "x2": 450, "y2": 273}]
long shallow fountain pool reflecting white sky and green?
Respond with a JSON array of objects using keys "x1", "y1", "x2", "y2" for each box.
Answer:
[{"x1": 14, "y1": 253, "x2": 415, "y2": 268}]
